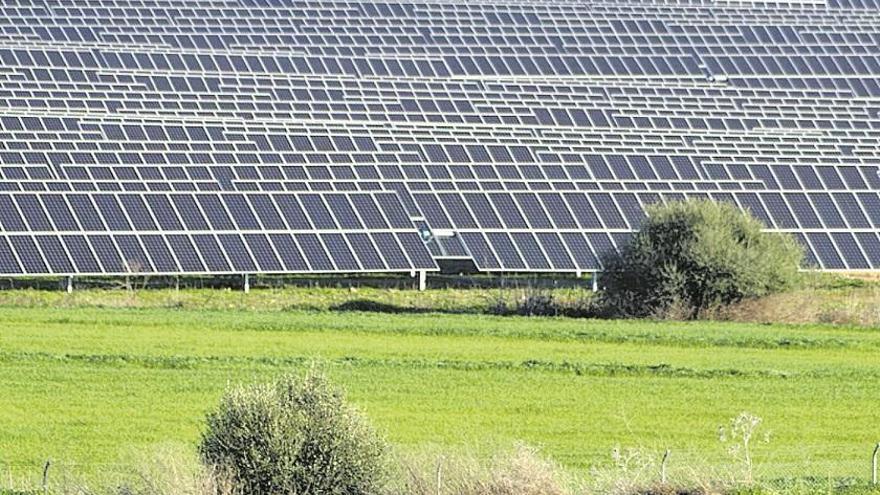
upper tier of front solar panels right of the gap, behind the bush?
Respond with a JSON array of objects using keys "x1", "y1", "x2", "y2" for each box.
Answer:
[{"x1": 413, "y1": 192, "x2": 880, "y2": 230}]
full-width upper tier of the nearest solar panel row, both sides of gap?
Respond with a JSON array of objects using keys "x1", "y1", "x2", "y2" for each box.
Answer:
[{"x1": 0, "y1": 192, "x2": 880, "y2": 232}]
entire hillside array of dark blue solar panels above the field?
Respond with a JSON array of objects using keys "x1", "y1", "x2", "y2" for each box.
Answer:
[{"x1": 0, "y1": 0, "x2": 880, "y2": 275}]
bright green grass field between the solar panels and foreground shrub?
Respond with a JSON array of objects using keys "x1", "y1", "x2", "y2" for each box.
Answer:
[{"x1": 0, "y1": 300, "x2": 880, "y2": 482}]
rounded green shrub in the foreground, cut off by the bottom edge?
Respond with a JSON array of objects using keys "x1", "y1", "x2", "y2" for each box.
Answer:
[{"x1": 199, "y1": 371, "x2": 387, "y2": 495}]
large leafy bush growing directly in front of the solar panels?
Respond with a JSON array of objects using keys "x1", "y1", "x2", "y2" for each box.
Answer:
[{"x1": 600, "y1": 200, "x2": 803, "y2": 318}]
